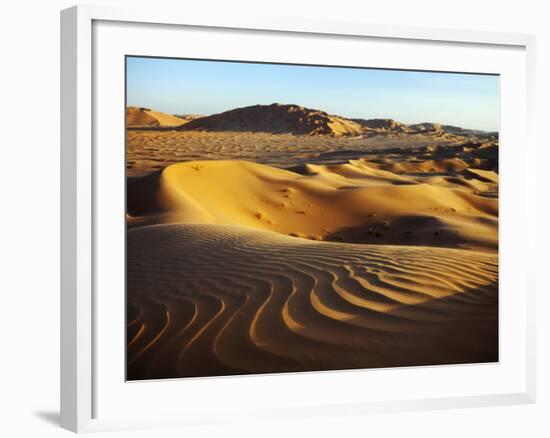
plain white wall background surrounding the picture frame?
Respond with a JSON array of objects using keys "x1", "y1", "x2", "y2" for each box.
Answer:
[{"x1": 0, "y1": 0, "x2": 550, "y2": 438}]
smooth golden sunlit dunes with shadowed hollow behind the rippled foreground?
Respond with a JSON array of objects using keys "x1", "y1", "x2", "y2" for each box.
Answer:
[{"x1": 128, "y1": 159, "x2": 498, "y2": 249}]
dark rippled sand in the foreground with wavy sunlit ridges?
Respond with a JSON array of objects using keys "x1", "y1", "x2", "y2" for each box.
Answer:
[{"x1": 127, "y1": 224, "x2": 498, "y2": 380}]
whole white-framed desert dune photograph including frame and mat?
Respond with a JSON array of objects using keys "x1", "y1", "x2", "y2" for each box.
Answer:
[{"x1": 61, "y1": 7, "x2": 535, "y2": 431}]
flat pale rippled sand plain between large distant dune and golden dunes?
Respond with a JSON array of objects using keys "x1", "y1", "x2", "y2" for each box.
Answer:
[{"x1": 126, "y1": 130, "x2": 492, "y2": 175}]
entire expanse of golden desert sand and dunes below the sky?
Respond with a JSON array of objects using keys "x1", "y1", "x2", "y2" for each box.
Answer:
[{"x1": 127, "y1": 104, "x2": 498, "y2": 380}]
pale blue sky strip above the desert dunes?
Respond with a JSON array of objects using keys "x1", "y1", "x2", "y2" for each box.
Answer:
[{"x1": 127, "y1": 57, "x2": 499, "y2": 131}]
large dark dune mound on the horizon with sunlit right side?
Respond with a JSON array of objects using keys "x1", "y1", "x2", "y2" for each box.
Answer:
[{"x1": 180, "y1": 103, "x2": 363, "y2": 136}]
